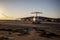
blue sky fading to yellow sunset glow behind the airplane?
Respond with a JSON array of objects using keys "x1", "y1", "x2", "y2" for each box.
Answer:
[{"x1": 0, "y1": 0, "x2": 60, "y2": 19}]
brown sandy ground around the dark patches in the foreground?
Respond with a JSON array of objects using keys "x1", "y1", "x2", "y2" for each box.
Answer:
[{"x1": 0, "y1": 22, "x2": 60, "y2": 40}]
